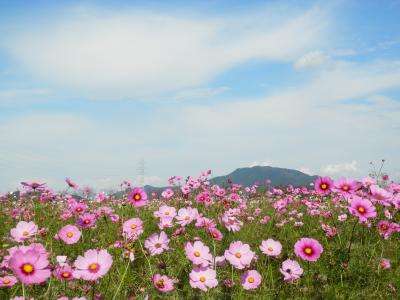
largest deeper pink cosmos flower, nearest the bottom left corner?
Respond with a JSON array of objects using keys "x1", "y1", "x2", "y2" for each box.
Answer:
[{"x1": 8, "y1": 248, "x2": 51, "y2": 285}]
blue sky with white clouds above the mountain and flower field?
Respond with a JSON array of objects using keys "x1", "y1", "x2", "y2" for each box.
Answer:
[{"x1": 0, "y1": 0, "x2": 400, "y2": 191}]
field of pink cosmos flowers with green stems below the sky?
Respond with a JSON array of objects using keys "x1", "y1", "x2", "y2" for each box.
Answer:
[{"x1": 0, "y1": 172, "x2": 400, "y2": 300}]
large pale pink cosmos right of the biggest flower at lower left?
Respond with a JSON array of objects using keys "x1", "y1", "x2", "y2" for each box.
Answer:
[{"x1": 73, "y1": 249, "x2": 113, "y2": 281}]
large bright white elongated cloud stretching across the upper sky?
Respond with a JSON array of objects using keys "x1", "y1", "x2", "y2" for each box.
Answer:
[{"x1": 0, "y1": 7, "x2": 329, "y2": 98}]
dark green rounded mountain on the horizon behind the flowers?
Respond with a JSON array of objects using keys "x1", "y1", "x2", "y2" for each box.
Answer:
[{"x1": 210, "y1": 166, "x2": 318, "y2": 186}]
